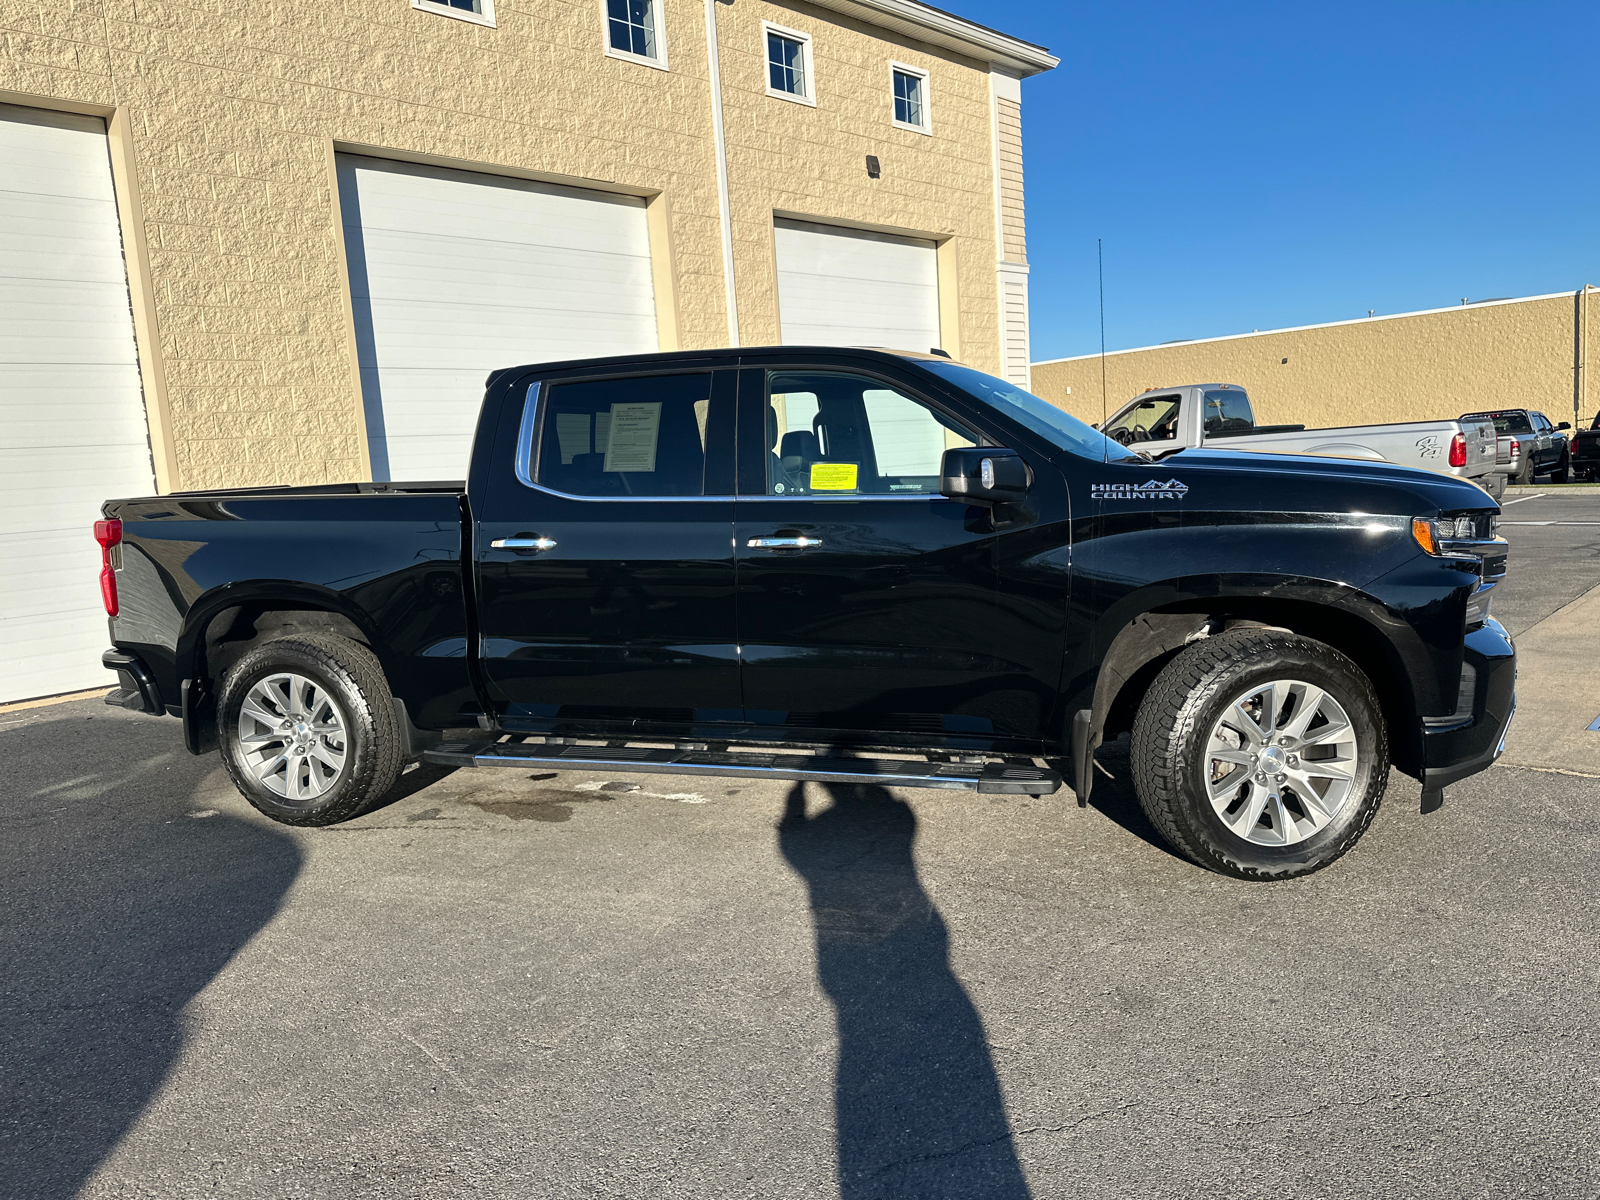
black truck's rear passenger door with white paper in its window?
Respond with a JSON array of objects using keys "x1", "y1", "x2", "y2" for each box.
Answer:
[{"x1": 474, "y1": 370, "x2": 741, "y2": 734}]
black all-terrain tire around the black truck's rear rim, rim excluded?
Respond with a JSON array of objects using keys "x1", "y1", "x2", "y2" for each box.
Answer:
[{"x1": 218, "y1": 634, "x2": 405, "y2": 826}]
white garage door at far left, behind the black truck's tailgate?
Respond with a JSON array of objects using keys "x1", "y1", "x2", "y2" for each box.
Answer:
[{"x1": 0, "y1": 104, "x2": 155, "y2": 701}]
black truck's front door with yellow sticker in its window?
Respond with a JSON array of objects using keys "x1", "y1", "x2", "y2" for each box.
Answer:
[{"x1": 734, "y1": 366, "x2": 1061, "y2": 746}]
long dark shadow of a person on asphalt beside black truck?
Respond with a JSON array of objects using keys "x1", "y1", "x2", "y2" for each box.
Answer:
[{"x1": 778, "y1": 784, "x2": 1032, "y2": 1200}]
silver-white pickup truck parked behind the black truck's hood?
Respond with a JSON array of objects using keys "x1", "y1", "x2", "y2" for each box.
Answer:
[{"x1": 1104, "y1": 384, "x2": 1506, "y2": 496}]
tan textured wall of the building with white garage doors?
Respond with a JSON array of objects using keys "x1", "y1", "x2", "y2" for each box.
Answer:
[{"x1": 0, "y1": 0, "x2": 1000, "y2": 488}]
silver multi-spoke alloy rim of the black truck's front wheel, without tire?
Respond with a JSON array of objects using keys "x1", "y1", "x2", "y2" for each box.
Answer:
[{"x1": 1205, "y1": 678, "x2": 1360, "y2": 846}]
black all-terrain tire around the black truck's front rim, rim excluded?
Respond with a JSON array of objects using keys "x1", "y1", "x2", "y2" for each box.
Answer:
[{"x1": 1133, "y1": 629, "x2": 1389, "y2": 880}]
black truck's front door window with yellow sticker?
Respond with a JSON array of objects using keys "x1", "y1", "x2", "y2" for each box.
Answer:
[{"x1": 766, "y1": 371, "x2": 978, "y2": 496}]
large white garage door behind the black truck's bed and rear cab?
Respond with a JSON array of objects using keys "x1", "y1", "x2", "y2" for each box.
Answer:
[{"x1": 339, "y1": 155, "x2": 658, "y2": 480}]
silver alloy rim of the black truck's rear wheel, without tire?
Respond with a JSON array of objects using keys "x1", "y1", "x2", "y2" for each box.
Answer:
[{"x1": 238, "y1": 672, "x2": 347, "y2": 800}]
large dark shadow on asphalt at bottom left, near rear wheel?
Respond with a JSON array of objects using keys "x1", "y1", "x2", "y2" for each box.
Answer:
[{"x1": 0, "y1": 718, "x2": 301, "y2": 1200}]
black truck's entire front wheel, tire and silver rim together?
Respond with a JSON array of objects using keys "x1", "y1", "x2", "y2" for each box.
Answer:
[{"x1": 1133, "y1": 629, "x2": 1389, "y2": 880}]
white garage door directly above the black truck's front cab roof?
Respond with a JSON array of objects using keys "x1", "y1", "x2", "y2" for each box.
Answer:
[{"x1": 774, "y1": 221, "x2": 939, "y2": 354}]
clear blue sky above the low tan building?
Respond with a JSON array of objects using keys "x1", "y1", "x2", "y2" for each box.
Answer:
[{"x1": 972, "y1": 0, "x2": 1600, "y2": 360}]
